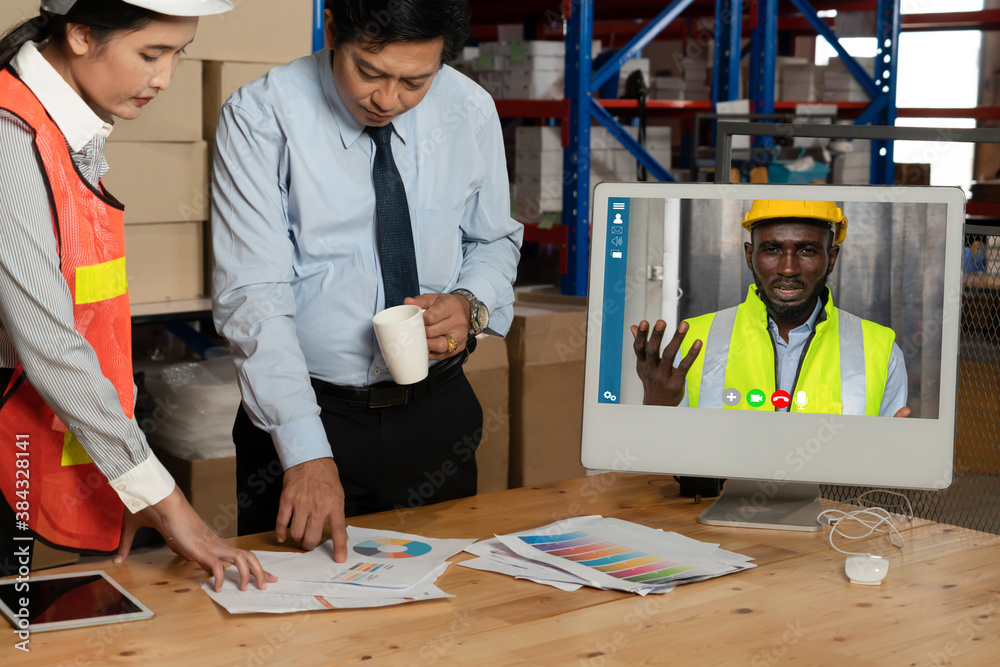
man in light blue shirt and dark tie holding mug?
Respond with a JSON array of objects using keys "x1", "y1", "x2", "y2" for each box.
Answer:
[{"x1": 212, "y1": 0, "x2": 522, "y2": 561}]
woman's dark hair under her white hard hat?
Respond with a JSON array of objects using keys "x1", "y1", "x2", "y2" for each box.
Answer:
[{"x1": 0, "y1": 0, "x2": 159, "y2": 69}]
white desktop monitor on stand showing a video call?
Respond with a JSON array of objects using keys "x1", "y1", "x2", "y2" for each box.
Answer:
[{"x1": 582, "y1": 183, "x2": 965, "y2": 530}]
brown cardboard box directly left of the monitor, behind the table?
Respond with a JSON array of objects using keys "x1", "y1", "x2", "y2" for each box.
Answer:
[{"x1": 506, "y1": 302, "x2": 587, "y2": 487}]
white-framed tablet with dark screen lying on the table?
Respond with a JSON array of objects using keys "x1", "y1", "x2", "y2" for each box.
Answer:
[{"x1": 0, "y1": 570, "x2": 155, "y2": 632}]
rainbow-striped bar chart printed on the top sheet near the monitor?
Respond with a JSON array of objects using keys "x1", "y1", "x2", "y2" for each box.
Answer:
[{"x1": 521, "y1": 531, "x2": 694, "y2": 586}]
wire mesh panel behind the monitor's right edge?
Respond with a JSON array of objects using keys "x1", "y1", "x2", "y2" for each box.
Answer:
[{"x1": 821, "y1": 226, "x2": 1000, "y2": 534}]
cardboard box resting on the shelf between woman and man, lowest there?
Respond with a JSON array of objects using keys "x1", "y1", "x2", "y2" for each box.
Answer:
[{"x1": 125, "y1": 222, "x2": 205, "y2": 304}]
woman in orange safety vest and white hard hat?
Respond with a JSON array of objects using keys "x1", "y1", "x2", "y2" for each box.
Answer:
[{"x1": 0, "y1": 0, "x2": 274, "y2": 590}]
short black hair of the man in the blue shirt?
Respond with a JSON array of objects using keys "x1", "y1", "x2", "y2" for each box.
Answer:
[{"x1": 326, "y1": 0, "x2": 470, "y2": 64}]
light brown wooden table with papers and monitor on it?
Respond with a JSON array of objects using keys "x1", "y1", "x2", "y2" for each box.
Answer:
[{"x1": 0, "y1": 473, "x2": 1000, "y2": 667}]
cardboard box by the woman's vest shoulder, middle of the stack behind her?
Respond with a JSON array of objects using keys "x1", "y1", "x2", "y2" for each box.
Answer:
[{"x1": 104, "y1": 141, "x2": 209, "y2": 225}]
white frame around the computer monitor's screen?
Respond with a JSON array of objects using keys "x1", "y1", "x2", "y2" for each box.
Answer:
[{"x1": 581, "y1": 183, "x2": 965, "y2": 489}]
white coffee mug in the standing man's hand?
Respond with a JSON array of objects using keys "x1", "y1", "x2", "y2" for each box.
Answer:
[{"x1": 372, "y1": 305, "x2": 430, "y2": 384}]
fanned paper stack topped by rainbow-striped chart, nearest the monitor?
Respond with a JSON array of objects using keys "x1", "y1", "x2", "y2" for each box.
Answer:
[{"x1": 459, "y1": 516, "x2": 756, "y2": 595}]
